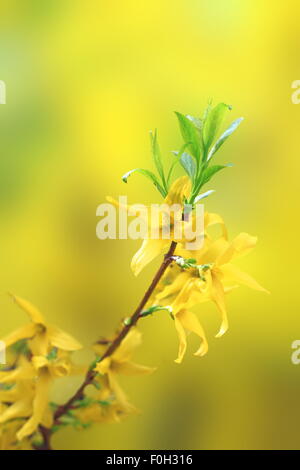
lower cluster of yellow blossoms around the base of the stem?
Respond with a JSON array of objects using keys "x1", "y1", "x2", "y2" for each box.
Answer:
[{"x1": 0, "y1": 296, "x2": 154, "y2": 450}]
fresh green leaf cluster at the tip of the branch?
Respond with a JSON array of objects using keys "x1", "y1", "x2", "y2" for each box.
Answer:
[{"x1": 122, "y1": 103, "x2": 243, "y2": 205}]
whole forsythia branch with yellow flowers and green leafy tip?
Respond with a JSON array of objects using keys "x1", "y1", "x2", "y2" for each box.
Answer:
[{"x1": 0, "y1": 103, "x2": 266, "y2": 450}]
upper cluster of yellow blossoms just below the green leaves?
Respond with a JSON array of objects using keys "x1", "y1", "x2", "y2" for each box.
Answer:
[{"x1": 113, "y1": 176, "x2": 267, "y2": 363}]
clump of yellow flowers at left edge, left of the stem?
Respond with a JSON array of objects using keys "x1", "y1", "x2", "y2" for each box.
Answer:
[{"x1": 0, "y1": 297, "x2": 81, "y2": 441}]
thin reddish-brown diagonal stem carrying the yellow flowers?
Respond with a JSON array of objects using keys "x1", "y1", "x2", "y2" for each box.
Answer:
[{"x1": 40, "y1": 241, "x2": 177, "y2": 450}]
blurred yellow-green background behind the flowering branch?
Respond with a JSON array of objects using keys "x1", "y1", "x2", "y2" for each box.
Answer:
[{"x1": 0, "y1": 0, "x2": 300, "y2": 449}]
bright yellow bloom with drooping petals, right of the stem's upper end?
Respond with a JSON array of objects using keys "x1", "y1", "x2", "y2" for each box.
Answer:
[{"x1": 151, "y1": 229, "x2": 267, "y2": 362}]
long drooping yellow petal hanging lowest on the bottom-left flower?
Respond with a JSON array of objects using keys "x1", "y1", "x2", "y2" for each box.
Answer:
[{"x1": 17, "y1": 371, "x2": 51, "y2": 440}]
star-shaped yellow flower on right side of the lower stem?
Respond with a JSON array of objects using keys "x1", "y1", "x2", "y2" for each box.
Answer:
[{"x1": 95, "y1": 328, "x2": 155, "y2": 410}]
